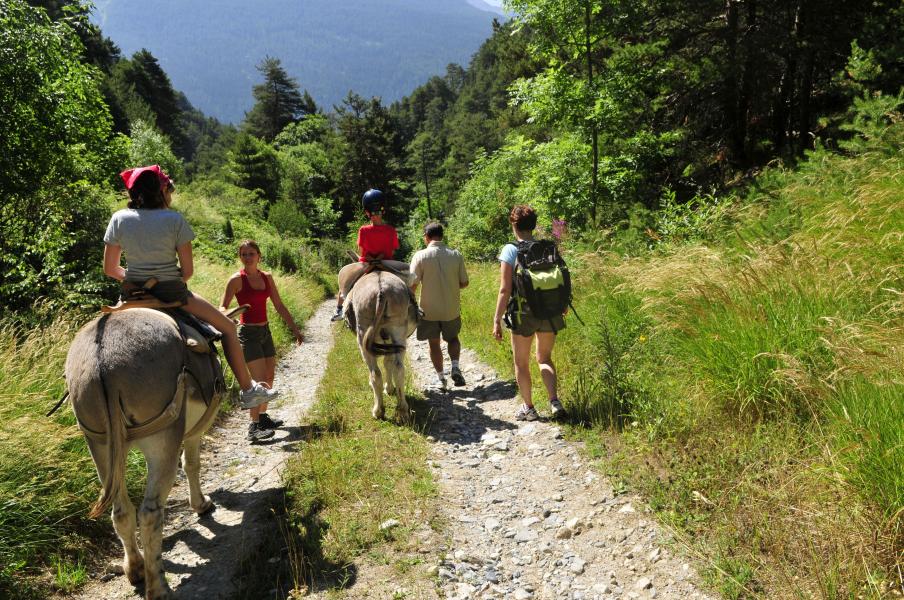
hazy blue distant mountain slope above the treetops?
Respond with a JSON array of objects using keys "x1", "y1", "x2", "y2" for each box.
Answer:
[{"x1": 94, "y1": 0, "x2": 498, "y2": 123}]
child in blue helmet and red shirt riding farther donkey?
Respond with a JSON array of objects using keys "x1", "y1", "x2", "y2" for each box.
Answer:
[{"x1": 332, "y1": 189, "x2": 408, "y2": 321}]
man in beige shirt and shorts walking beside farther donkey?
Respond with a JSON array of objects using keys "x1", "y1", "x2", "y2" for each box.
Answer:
[{"x1": 410, "y1": 221, "x2": 468, "y2": 389}]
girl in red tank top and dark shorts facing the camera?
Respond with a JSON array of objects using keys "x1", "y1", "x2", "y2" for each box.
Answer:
[{"x1": 220, "y1": 240, "x2": 304, "y2": 442}]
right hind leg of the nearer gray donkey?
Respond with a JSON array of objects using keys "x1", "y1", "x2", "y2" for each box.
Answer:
[{"x1": 138, "y1": 434, "x2": 182, "y2": 600}]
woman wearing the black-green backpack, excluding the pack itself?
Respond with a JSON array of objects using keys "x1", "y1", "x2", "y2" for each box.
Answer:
[{"x1": 493, "y1": 205, "x2": 570, "y2": 421}]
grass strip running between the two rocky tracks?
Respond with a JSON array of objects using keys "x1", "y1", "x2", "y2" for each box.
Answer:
[{"x1": 286, "y1": 326, "x2": 437, "y2": 587}]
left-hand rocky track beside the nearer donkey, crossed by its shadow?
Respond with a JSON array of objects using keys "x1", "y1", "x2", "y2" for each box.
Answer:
[{"x1": 76, "y1": 300, "x2": 335, "y2": 600}]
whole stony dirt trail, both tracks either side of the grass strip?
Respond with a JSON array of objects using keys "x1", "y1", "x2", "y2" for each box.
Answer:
[{"x1": 70, "y1": 301, "x2": 712, "y2": 600}]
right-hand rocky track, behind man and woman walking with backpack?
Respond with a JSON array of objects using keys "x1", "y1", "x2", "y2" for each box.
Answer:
[{"x1": 398, "y1": 339, "x2": 711, "y2": 600}]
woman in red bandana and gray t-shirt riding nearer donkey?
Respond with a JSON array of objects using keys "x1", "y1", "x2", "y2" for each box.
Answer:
[{"x1": 104, "y1": 165, "x2": 278, "y2": 408}]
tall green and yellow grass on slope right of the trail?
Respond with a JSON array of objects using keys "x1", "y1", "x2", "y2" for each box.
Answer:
[{"x1": 462, "y1": 135, "x2": 904, "y2": 599}]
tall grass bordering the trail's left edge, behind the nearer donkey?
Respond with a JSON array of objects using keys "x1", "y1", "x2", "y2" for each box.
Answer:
[{"x1": 0, "y1": 252, "x2": 324, "y2": 599}]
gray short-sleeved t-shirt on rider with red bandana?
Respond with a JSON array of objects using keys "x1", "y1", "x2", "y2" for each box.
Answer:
[{"x1": 104, "y1": 208, "x2": 195, "y2": 282}]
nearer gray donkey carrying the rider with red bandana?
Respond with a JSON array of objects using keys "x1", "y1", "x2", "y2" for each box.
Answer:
[{"x1": 66, "y1": 308, "x2": 222, "y2": 600}]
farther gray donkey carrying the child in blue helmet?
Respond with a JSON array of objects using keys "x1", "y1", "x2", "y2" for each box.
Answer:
[{"x1": 349, "y1": 271, "x2": 417, "y2": 423}]
